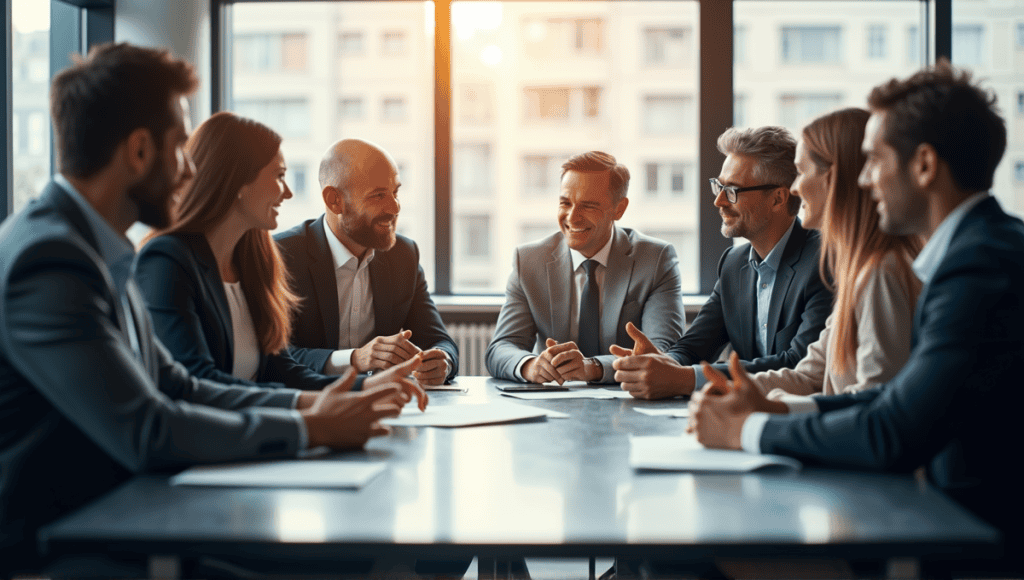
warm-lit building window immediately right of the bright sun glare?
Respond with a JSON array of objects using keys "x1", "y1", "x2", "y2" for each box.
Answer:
[{"x1": 522, "y1": 16, "x2": 604, "y2": 58}]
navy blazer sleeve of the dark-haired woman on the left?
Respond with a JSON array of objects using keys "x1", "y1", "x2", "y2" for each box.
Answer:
[{"x1": 135, "y1": 240, "x2": 285, "y2": 388}]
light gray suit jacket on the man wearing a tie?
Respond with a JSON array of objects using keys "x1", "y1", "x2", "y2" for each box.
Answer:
[{"x1": 486, "y1": 227, "x2": 684, "y2": 382}]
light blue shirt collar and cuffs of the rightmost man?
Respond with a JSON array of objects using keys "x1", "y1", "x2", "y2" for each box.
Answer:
[{"x1": 740, "y1": 192, "x2": 988, "y2": 453}]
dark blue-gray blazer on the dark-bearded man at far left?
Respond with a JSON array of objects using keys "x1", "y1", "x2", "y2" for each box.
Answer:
[{"x1": 0, "y1": 183, "x2": 300, "y2": 576}]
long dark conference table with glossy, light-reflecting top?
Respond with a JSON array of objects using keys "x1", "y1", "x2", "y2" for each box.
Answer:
[{"x1": 39, "y1": 377, "x2": 1000, "y2": 580}]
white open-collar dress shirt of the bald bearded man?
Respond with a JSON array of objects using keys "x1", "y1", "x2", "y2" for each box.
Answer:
[{"x1": 324, "y1": 227, "x2": 375, "y2": 374}]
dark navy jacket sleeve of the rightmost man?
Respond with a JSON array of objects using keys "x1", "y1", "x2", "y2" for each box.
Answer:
[{"x1": 761, "y1": 240, "x2": 1007, "y2": 470}]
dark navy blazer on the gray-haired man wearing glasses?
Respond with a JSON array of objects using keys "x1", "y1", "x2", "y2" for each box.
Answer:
[{"x1": 668, "y1": 218, "x2": 833, "y2": 377}]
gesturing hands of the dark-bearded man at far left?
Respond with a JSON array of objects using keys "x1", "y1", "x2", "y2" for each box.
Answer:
[{"x1": 296, "y1": 354, "x2": 427, "y2": 449}]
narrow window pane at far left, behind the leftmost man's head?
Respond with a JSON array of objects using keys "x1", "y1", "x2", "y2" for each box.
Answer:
[{"x1": 10, "y1": 0, "x2": 50, "y2": 211}]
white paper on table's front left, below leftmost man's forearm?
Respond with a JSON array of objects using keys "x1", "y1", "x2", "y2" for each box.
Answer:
[{"x1": 171, "y1": 460, "x2": 386, "y2": 489}]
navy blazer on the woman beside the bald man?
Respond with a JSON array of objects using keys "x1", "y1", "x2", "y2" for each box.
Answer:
[{"x1": 135, "y1": 233, "x2": 337, "y2": 390}]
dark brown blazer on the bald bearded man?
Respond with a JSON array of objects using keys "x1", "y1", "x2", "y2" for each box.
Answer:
[{"x1": 274, "y1": 215, "x2": 459, "y2": 379}]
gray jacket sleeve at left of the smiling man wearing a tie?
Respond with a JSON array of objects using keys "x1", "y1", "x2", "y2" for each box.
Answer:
[{"x1": 485, "y1": 249, "x2": 537, "y2": 380}]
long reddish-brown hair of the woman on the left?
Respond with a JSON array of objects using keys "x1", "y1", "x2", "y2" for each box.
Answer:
[{"x1": 149, "y1": 112, "x2": 299, "y2": 355}]
